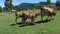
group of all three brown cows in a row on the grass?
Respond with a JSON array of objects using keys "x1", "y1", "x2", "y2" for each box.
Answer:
[{"x1": 12, "y1": 6, "x2": 56, "y2": 24}]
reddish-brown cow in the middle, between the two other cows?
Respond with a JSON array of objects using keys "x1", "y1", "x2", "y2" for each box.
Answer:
[{"x1": 24, "y1": 12, "x2": 40, "y2": 24}]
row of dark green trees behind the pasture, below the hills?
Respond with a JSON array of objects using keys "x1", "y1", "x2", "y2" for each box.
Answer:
[{"x1": 0, "y1": 0, "x2": 60, "y2": 13}]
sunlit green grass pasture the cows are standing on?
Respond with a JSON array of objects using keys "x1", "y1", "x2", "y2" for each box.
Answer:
[{"x1": 0, "y1": 9, "x2": 60, "y2": 34}]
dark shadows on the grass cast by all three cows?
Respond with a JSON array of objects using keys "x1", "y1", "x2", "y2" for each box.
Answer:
[{"x1": 10, "y1": 19, "x2": 53, "y2": 27}]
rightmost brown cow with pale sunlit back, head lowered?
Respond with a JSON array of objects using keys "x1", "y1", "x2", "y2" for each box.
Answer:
[{"x1": 41, "y1": 6, "x2": 56, "y2": 20}]
